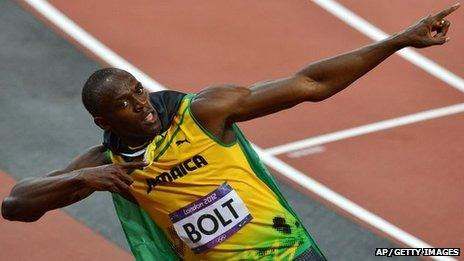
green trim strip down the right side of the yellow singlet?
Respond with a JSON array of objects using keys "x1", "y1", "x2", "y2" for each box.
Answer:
[{"x1": 233, "y1": 124, "x2": 327, "y2": 259}]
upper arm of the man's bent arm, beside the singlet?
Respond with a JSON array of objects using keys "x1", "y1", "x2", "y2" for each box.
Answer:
[{"x1": 47, "y1": 145, "x2": 110, "y2": 177}]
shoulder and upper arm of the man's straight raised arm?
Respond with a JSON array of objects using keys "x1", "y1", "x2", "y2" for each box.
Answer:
[{"x1": 192, "y1": 75, "x2": 319, "y2": 125}]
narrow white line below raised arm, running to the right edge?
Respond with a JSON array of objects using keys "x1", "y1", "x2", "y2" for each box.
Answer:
[{"x1": 265, "y1": 103, "x2": 464, "y2": 155}]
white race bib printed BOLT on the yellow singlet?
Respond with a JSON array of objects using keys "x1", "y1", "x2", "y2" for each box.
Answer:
[{"x1": 169, "y1": 183, "x2": 253, "y2": 253}]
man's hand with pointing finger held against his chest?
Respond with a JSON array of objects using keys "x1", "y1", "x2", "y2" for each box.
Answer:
[{"x1": 82, "y1": 162, "x2": 147, "y2": 194}]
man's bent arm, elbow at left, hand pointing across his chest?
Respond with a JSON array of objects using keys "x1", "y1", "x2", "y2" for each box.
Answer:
[{"x1": 2, "y1": 146, "x2": 145, "y2": 222}]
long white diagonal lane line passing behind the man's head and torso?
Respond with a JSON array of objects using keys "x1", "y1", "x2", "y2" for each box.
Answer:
[{"x1": 25, "y1": 0, "x2": 450, "y2": 256}]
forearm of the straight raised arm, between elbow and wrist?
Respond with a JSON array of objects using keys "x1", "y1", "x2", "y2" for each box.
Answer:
[{"x1": 297, "y1": 35, "x2": 406, "y2": 100}]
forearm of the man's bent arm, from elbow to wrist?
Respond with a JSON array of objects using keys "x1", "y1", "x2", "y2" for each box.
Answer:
[{"x1": 2, "y1": 170, "x2": 94, "y2": 222}]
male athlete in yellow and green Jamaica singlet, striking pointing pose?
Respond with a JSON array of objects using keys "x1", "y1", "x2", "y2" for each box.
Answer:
[{"x1": 2, "y1": 4, "x2": 459, "y2": 260}]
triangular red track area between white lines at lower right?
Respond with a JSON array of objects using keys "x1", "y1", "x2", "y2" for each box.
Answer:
[{"x1": 281, "y1": 114, "x2": 464, "y2": 247}]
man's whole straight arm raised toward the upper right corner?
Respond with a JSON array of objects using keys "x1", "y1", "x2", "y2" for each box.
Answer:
[{"x1": 192, "y1": 4, "x2": 459, "y2": 137}]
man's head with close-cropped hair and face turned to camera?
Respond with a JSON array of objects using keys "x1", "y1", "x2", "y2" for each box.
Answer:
[{"x1": 82, "y1": 68, "x2": 161, "y2": 137}]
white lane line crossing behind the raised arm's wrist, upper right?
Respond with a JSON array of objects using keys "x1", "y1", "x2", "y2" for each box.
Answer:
[{"x1": 312, "y1": 0, "x2": 464, "y2": 92}]
